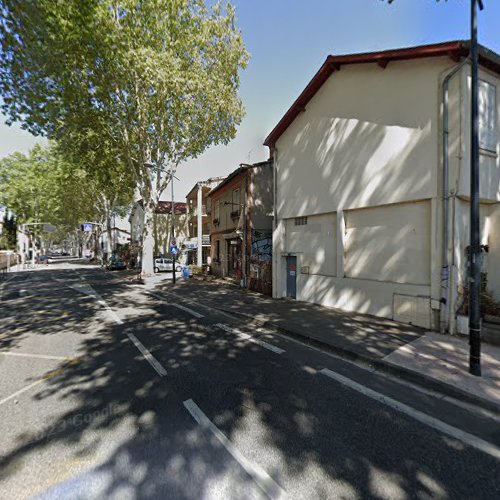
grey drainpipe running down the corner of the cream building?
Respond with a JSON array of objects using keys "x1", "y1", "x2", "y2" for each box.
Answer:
[{"x1": 441, "y1": 58, "x2": 469, "y2": 330}]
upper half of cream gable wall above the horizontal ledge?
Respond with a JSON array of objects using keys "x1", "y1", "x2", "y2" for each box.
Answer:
[{"x1": 276, "y1": 58, "x2": 454, "y2": 218}]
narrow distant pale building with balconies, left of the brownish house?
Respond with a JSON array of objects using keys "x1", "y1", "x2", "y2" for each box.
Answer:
[{"x1": 185, "y1": 177, "x2": 225, "y2": 267}]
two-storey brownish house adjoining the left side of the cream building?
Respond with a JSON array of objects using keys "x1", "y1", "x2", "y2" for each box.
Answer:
[{"x1": 208, "y1": 161, "x2": 273, "y2": 294}]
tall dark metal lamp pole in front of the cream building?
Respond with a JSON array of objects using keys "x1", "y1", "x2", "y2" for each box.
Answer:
[{"x1": 469, "y1": 0, "x2": 482, "y2": 376}]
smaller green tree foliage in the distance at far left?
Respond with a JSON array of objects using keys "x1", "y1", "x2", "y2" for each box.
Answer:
[{"x1": 0, "y1": 144, "x2": 133, "y2": 253}]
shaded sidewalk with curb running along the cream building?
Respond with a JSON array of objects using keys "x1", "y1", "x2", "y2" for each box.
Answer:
[{"x1": 159, "y1": 279, "x2": 500, "y2": 414}]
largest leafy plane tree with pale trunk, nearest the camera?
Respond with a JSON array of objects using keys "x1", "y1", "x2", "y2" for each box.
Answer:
[{"x1": 0, "y1": 0, "x2": 247, "y2": 274}]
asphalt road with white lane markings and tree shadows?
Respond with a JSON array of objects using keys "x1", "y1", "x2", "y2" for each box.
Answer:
[{"x1": 0, "y1": 263, "x2": 500, "y2": 499}]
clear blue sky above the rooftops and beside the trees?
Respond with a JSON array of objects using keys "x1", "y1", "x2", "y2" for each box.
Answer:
[{"x1": 0, "y1": 0, "x2": 500, "y2": 201}]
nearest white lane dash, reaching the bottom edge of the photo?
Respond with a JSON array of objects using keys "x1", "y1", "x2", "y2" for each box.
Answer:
[{"x1": 184, "y1": 399, "x2": 287, "y2": 499}]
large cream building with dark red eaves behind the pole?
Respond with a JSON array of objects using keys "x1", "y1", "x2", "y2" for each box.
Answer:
[{"x1": 265, "y1": 42, "x2": 500, "y2": 332}]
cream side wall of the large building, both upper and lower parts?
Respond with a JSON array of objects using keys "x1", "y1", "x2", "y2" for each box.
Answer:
[{"x1": 273, "y1": 58, "x2": 462, "y2": 327}]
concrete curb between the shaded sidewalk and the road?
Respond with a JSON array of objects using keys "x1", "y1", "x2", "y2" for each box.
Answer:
[{"x1": 218, "y1": 307, "x2": 500, "y2": 416}]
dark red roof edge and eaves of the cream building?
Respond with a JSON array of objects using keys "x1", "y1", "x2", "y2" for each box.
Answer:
[{"x1": 264, "y1": 40, "x2": 500, "y2": 149}]
